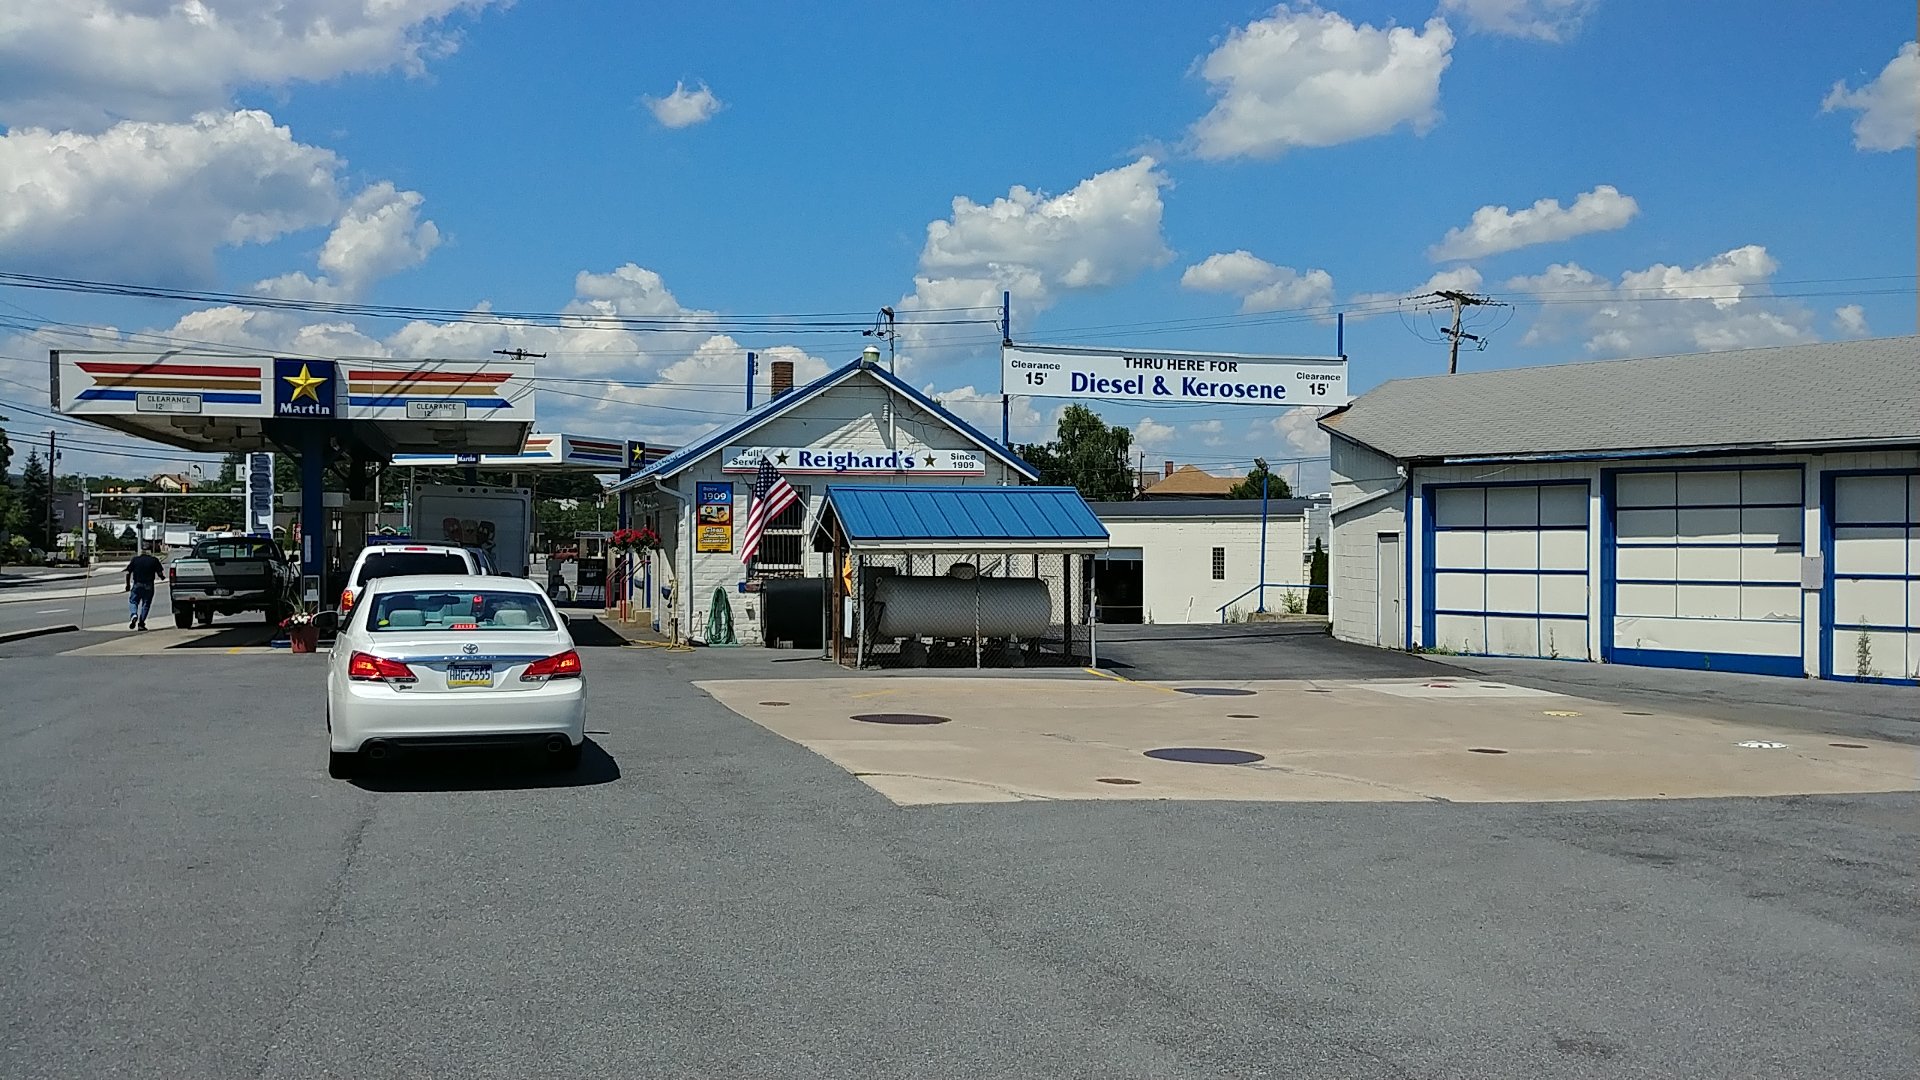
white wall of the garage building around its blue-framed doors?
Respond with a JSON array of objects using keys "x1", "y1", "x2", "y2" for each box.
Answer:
[{"x1": 1331, "y1": 434, "x2": 1920, "y2": 676}]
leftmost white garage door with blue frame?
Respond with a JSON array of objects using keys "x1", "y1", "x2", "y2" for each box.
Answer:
[{"x1": 1425, "y1": 480, "x2": 1588, "y2": 659}]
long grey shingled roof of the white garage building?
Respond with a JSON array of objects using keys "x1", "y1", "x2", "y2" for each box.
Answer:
[{"x1": 1321, "y1": 336, "x2": 1920, "y2": 459}]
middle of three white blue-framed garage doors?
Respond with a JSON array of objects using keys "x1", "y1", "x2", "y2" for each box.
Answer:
[{"x1": 1607, "y1": 467, "x2": 1805, "y2": 675}]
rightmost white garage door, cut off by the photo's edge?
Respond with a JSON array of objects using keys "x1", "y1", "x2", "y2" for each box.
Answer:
[{"x1": 1822, "y1": 473, "x2": 1920, "y2": 682}]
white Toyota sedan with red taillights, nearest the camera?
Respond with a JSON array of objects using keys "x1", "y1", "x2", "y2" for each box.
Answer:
[{"x1": 326, "y1": 575, "x2": 586, "y2": 778}]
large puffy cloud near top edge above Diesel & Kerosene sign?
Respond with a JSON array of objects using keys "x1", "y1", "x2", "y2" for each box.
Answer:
[{"x1": 1188, "y1": 4, "x2": 1453, "y2": 160}]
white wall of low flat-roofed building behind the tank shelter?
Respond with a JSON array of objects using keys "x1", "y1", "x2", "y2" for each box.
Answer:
[{"x1": 1102, "y1": 515, "x2": 1308, "y2": 623}]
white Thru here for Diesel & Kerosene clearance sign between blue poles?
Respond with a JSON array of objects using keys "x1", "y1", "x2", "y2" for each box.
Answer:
[{"x1": 1000, "y1": 346, "x2": 1352, "y2": 407}]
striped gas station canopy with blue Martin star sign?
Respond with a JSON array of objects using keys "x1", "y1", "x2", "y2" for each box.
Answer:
[{"x1": 48, "y1": 350, "x2": 533, "y2": 455}]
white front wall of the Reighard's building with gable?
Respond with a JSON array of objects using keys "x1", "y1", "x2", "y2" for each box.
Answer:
[{"x1": 636, "y1": 375, "x2": 1023, "y2": 644}]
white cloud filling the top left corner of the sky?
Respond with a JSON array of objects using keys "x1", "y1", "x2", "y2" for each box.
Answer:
[{"x1": 0, "y1": 0, "x2": 490, "y2": 131}]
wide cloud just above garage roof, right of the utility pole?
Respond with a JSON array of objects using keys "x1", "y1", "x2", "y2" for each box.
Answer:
[{"x1": 1505, "y1": 244, "x2": 1814, "y2": 357}]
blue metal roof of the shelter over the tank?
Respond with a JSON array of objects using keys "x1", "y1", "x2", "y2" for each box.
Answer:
[{"x1": 814, "y1": 484, "x2": 1108, "y2": 552}]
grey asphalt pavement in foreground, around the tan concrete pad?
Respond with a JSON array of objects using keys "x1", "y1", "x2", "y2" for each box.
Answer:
[{"x1": 0, "y1": 634, "x2": 1920, "y2": 1080}]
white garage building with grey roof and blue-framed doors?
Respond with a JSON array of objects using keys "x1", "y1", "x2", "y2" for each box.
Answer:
[{"x1": 1320, "y1": 338, "x2": 1920, "y2": 682}]
